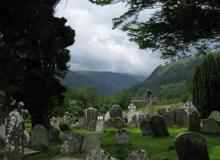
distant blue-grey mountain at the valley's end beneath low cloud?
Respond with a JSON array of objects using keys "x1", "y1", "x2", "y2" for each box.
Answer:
[{"x1": 61, "y1": 71, "x2": 145, "y2": 95}]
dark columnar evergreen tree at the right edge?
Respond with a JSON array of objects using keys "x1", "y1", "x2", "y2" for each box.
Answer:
[{"x1": 193, "y1": 54, "x2": 220, "y2": 118}]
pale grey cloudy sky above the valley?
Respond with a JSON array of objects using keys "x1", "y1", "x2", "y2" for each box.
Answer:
[{"x1": 56, "y1": 0, "x2": 163, "y2": 76}]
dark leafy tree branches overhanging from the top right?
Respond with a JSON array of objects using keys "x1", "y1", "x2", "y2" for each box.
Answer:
[{"x1": 90, "y1": 0, "x2": 220, "y2": 58}]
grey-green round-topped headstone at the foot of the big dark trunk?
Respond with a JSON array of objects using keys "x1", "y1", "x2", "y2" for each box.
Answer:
[{"x1": 31, "y1": 124, "x2": 49, "y2": 151}]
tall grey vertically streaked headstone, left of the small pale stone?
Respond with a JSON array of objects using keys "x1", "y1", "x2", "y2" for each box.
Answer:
[{"x1": 84, "y1": 107, "x2": 98, "y2": 130}]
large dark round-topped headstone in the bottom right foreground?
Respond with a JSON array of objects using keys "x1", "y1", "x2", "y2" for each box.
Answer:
[{"x1": 175, "y1": 132, "x2": 209, "y2": 160}]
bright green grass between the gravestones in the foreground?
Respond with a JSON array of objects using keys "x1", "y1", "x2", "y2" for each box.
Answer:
[{"x1": 0, "y1": 126, "x2": 220, "y2": 160}]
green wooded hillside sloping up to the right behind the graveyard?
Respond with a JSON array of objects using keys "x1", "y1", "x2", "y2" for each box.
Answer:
[{"x1": 129, "y1": 56, "x2": 204, "y2": 101}]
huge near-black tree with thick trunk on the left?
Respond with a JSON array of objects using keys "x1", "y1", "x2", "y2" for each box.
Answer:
[{"x1": 0, "y1": 0, "x2": 75, "y2": 128}]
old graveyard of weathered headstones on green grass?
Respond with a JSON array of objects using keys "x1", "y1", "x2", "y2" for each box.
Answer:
[{"x1": 0, "y1": 102, "x2": 220, "y2": 160}]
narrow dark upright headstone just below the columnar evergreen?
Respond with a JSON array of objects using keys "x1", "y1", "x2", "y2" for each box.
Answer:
[{"x1": 189, "y1": 111, "x2": 201, "y2": 132}]
